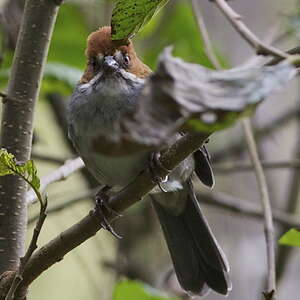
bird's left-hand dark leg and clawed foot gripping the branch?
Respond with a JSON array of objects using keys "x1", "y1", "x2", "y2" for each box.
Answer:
[{"x1": 95, "y1": 185, "x2": 122, "y2": 239}]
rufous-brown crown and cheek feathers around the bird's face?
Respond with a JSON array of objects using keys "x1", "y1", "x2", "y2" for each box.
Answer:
[{"x1": 80, "y1": 26, "x2": 152, "y2": 83}]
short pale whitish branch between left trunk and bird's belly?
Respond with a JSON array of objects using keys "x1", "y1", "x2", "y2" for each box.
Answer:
[{"x1": 26, "y1": 157, "x2": 84, "y2": 204}]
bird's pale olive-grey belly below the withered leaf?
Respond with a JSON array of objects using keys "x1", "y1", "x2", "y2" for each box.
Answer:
[{"x1": 82, "y1": 148, "x2": 149, "y2": 187}]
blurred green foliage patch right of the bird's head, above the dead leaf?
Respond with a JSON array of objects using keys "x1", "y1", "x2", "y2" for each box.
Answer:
[{"x1": 137, "y1": 1, "x2": 220, "y2": 69}]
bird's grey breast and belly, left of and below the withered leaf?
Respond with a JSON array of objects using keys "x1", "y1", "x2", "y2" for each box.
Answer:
[{"x1": 68, "y1": 74, "x2": 149, "y2": 186}]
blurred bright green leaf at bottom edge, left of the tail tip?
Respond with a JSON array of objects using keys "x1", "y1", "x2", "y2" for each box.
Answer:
[{"x1": 113, "y1": 280, "x2": 179, "y2": 300}]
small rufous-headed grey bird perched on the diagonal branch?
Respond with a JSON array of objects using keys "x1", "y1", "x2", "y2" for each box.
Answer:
[{"x1": 68, "y1": 27, "x2": 231, "y2": 295}]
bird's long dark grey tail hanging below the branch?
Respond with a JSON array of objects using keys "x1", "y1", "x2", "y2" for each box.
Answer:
[{"x1": 151, "y1": 181, "x2": 231, "y2": 295}]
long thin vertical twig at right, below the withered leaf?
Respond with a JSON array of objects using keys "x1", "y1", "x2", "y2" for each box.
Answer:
[{"x1": 242, "y1": 118, "x2": 276, "y2": 299}]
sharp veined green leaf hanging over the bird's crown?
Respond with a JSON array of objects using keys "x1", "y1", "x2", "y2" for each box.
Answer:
[{"x1": 111, "y1": 0, "x2": 168, "y2": 40}]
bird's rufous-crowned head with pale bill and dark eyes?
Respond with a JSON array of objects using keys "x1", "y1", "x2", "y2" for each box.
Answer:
[{"x1": 81, "y1": 26, "x2": 151, "y2": 83}]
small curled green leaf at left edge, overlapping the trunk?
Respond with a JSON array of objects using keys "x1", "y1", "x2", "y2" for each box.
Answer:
[{"x1": 0, "y1": 149, "x2": 40, "y2": 190}]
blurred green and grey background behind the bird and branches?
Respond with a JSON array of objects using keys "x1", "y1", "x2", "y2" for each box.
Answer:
[{"x1": 0, "y1": 0, "x2": 300, "y2": 300}]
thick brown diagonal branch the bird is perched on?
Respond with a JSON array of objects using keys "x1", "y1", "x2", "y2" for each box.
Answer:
[{"x1": 13, "y1": 133, "x2": 208, "y2": 292}]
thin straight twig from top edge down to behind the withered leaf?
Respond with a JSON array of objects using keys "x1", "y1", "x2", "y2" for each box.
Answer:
[{"x1": 191, "y1": 0, "x2": 222, "y2": 70}]
